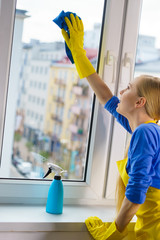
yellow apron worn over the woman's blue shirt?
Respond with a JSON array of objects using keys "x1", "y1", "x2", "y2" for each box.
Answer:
[{"x1": 117, "y1": 158, "x2": 160, "y2": 240}]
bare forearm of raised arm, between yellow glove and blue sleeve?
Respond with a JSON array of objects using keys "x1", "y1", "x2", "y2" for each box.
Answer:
[{"x1": 87, "y1": 73, "x2": 113, "y2": 105}]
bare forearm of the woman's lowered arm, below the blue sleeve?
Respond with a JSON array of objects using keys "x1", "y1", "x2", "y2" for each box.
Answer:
[{"x1": 115, "y1": 197, "x2": 141, "y2": 232}]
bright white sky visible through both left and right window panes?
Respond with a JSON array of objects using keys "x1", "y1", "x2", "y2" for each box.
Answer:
[{"x1": 17, "y1": 0, "x2": 160, "y2": 46}]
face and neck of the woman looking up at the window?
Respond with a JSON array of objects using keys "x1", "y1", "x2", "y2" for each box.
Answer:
[{"x1": 116, "y1": 78, "x2": 140, "y2": 117}]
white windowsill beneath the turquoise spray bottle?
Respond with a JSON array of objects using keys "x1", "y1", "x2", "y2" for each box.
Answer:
[{"x1": 0, "y1": 204, "x2": 135, "y2": 232}]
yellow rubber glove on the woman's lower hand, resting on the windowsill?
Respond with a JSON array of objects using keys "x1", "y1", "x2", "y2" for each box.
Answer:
[{"x1": 85, "y1": 217, "x2": 127, "y2": 240}]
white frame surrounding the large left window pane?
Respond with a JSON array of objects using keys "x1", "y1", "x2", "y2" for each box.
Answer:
[{"x1": 0, "y1": 0, "x2": 141, "y2": 204}]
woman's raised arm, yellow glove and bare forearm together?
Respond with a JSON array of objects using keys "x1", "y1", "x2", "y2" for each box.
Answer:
[{"x1": 62, "y1": 14, "x2": 113, "y2": 105}]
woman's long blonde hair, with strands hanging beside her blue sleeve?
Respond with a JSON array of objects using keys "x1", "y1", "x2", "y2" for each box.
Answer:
[{"x1": 116, "y1": 75, "x2": 160, "y2": 214}]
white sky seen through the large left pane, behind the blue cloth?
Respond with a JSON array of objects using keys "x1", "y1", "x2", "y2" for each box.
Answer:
[{"x1": 16, "y1": 0, "x2": 104, "y2": 42}]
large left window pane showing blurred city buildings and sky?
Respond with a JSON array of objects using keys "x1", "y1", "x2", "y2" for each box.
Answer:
[{"x1": 2, "y1": 0, "x2": 103, "y2": 180}]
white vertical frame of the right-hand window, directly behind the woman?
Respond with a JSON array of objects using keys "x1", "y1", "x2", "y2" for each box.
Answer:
[{"x1": 105, "y1": 0, "x2": 143, "y2": 200}]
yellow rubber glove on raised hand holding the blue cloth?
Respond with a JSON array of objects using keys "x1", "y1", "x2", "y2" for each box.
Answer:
[{"x1": 62, "y1": 14, "x2": 95, "y2": 78}]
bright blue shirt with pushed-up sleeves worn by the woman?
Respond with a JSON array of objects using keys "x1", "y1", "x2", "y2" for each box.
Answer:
[{"x1": 104, "y1": 96, "x2": 160, "y2": 204}]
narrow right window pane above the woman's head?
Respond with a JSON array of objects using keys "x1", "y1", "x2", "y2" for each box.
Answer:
[{"x1": 135, "y1": 0, "x2": 160, "y2": 77}]
